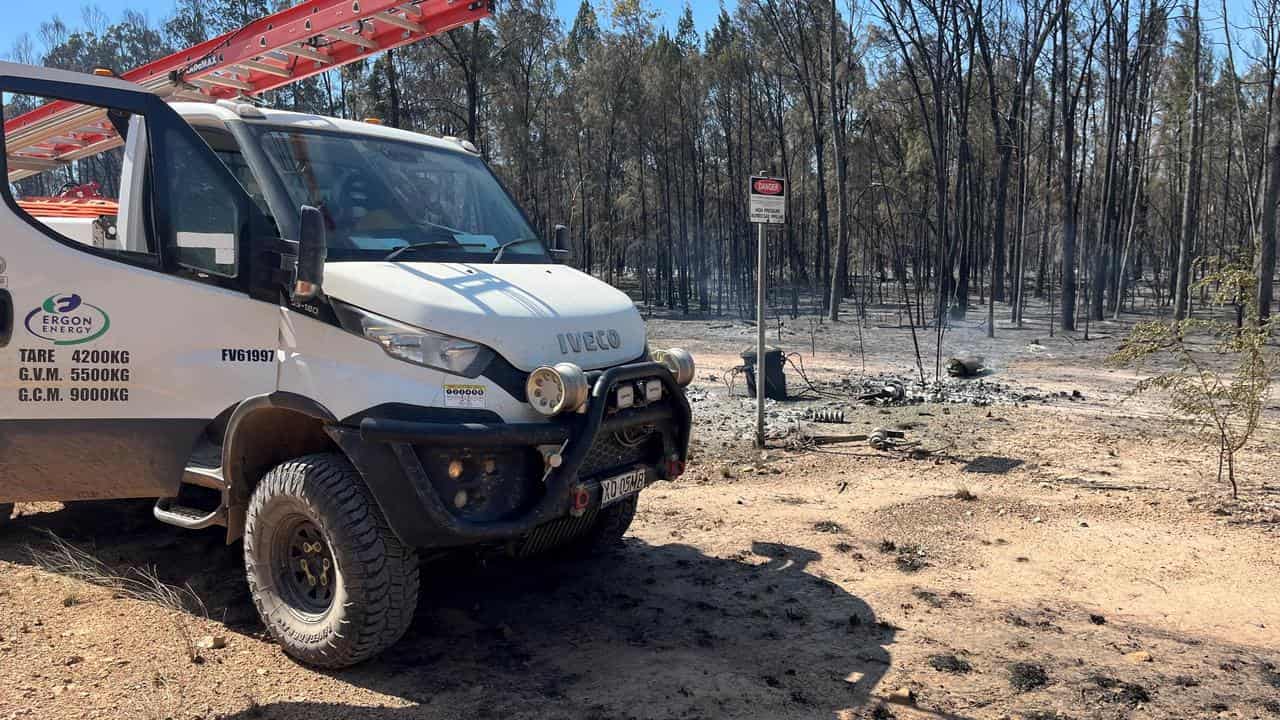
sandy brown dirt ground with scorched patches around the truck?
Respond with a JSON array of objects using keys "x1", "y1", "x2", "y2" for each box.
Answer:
[{"x1": 0, "y1": 298, "x2": 1280, "y2": 720}]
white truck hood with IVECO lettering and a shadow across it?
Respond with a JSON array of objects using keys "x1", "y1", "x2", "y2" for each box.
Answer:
[{"x1": 324, "y1": 263, "x2": 645, "y2": 372}]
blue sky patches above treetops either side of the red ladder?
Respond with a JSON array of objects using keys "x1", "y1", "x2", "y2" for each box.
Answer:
[{"x1": 0, "y1": 0, "x2": 719, "y2": 56}]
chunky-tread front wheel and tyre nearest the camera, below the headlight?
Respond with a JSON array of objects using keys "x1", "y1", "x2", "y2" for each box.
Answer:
[{"x1": 244, "y1": 454, "x2": 419, "y2": 669}]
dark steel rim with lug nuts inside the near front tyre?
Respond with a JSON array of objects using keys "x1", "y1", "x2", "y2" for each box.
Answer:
[{"x1": 273, "y1": 515, "x2": 338, "y2": 620}]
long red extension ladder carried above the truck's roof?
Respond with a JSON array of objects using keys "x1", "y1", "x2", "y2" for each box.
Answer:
[{"x1": 4, "y1": 0, "x2": 493, "y2": 182}]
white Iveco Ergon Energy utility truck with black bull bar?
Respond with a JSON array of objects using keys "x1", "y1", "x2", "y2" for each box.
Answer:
[{"x1": 0, "y1": 63, "x2": 694, "y2": 667}]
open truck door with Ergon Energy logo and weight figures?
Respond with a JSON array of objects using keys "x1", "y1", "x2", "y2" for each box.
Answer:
[{"x1": 0, "y1": 63, "x2": 280, "y2": 502}]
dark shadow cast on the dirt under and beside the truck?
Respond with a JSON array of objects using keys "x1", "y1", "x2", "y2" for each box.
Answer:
[{"x1": 0, "y1": 502, "x2": 895, "y2": 720}]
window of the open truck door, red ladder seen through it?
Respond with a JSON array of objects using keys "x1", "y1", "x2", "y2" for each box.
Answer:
[{"x1": 4, "y1": 94, "x2": 246, "y2": 278}]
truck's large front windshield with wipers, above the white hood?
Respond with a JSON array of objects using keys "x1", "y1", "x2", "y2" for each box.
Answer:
[{"x1": 260, "y1": 128, "x2": 549, "y2": 263}]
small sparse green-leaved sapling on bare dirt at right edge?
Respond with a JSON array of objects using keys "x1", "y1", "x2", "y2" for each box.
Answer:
[{"x1": 1110, "y1": 263, "x2": 1280, "y2": 496}]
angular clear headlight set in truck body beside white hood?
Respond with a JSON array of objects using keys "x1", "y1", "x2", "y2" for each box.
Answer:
[{"x1": 335, "y1": 304, "x2": 493, "y2": 378}]
